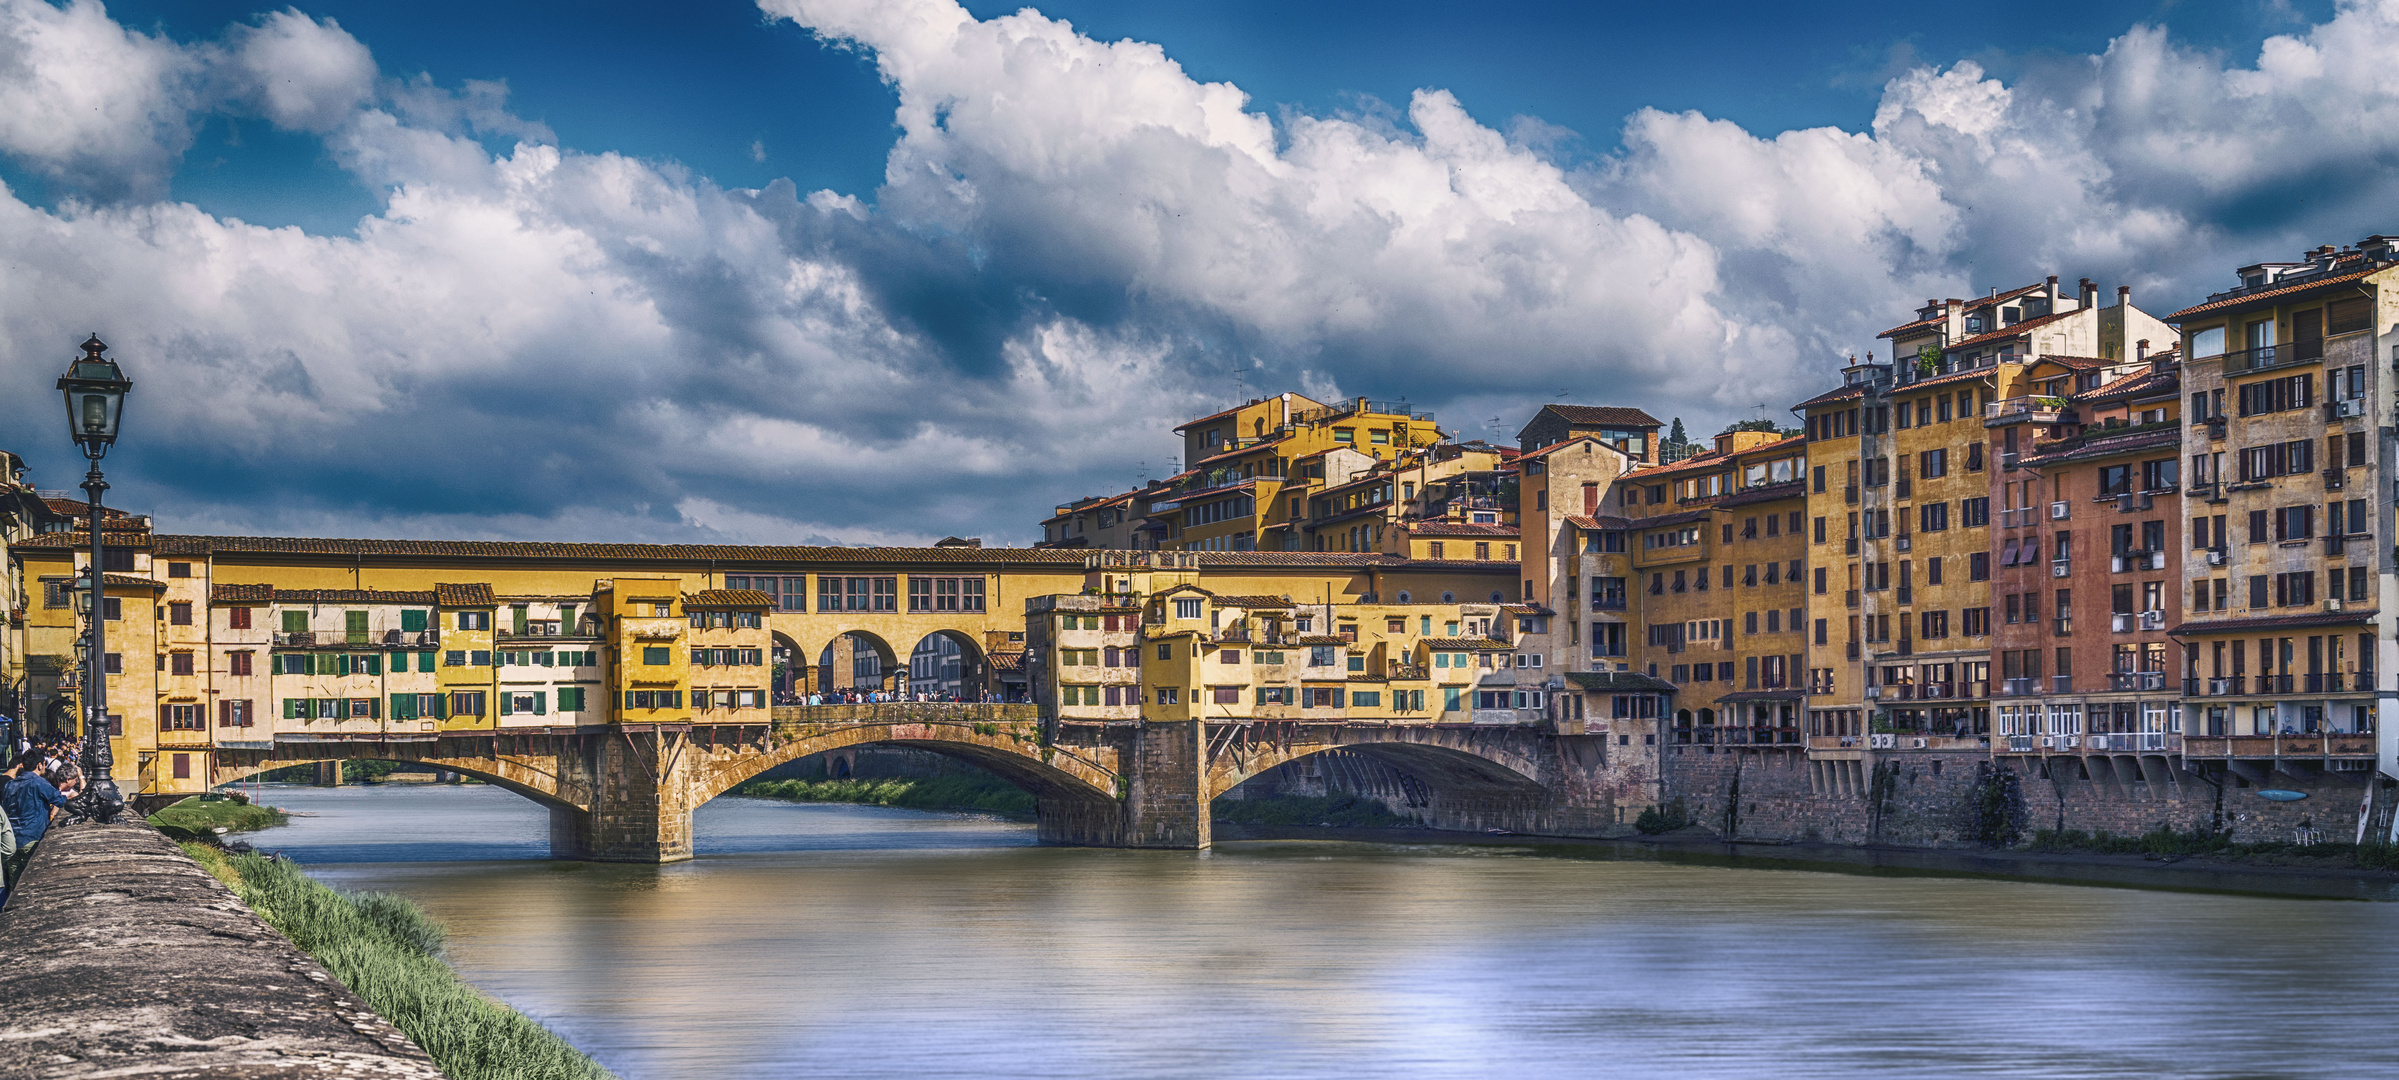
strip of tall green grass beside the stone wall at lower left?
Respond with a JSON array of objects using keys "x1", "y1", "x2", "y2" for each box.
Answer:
[{"x1": 182, "y1": 842, "x2": 614, "y2": 1080}]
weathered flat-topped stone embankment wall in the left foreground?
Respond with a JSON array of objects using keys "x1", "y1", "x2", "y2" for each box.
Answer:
[{"x1": 0, "y1": 823, "x2": 441, "y2": 1080}]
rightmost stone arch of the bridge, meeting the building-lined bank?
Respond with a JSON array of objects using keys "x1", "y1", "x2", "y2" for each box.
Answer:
[{"x1": 1207, "y1": 727, "x2": 1543, "y2": 799}]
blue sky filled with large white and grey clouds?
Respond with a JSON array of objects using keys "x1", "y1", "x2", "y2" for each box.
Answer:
[{"x1": 0, "y1": 0, "x2": 2370, "y2": 542}]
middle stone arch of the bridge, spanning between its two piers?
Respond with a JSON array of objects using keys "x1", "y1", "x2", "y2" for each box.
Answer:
[{"x1": 691, "y1": 720, "x2": 1123, "y2": 816}]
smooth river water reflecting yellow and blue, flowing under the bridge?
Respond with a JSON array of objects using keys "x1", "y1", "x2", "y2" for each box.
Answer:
[{"x1": 254, "y1": 785, "x2": 2399, "y2": 1080}]
